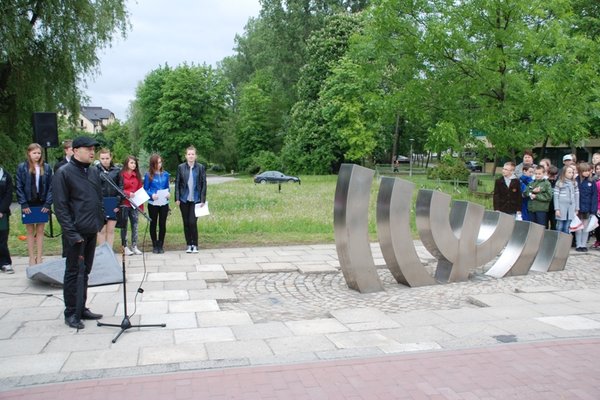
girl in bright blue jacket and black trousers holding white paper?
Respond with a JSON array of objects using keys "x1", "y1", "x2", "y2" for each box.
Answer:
[{"x1": 144, "y1": 154, "x2": 170, "y2": 254}]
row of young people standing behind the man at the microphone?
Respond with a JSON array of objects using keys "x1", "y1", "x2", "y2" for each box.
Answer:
[{"x1": 0, "y1": 140, "x2": 206, "y2": 273}]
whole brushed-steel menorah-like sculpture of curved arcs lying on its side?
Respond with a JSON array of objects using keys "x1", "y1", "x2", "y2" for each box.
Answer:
[{"x1": 334, "y1": 164, "x2": 570, "y2": 293}]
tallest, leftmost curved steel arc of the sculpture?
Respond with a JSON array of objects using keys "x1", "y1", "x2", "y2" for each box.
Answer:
[{"x1": 333, "y1": 164, "x2": 383, "y2": 293}]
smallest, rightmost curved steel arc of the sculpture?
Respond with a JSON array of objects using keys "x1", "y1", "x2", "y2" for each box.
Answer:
[{"x1": 530, "y1": 230, "x2": 571, "y2": 272}]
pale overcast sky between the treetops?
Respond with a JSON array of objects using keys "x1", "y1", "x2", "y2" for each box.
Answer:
[{"x1": 82, "y1": 0, "x2": 260, "y2": 121}]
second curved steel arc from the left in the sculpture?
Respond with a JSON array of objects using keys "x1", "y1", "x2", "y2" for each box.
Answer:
[{"x1": 377, "y1": 177, "x2": 436, "y2": 287}]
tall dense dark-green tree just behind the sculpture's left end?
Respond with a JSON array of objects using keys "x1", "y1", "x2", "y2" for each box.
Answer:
[{"x1": 282, "y1": 14, "x2": 371, "y2": 174}]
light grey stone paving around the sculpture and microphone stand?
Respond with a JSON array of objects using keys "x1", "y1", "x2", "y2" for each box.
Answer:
[{"x1": 0, "y1": 243, "x2": 600, "y2": 398}]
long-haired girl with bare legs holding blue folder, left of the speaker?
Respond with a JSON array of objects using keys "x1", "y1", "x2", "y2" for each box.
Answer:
[{"x1": 16, "y1": 143, "x2": 52, "y2": 265}]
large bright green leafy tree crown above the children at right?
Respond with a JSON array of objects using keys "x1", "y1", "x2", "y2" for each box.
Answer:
[{"x1": 342, "y1": 0, "x2": 600, "y2": 166}]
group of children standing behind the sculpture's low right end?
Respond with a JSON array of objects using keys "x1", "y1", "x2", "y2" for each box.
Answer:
[{"x1": 494, "y1": 153, "x2": 600, "y2": 252}]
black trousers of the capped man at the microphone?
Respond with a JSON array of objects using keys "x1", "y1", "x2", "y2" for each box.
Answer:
[{"x1": 63, "y1": 233, "x2": 97, "y2": 318}]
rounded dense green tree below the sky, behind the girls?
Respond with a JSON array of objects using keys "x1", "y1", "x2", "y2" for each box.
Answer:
[{"x1": 136, "y1": 64, "x2": 229, "y2": 170}]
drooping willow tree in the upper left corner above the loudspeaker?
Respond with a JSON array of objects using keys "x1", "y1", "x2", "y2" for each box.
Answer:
[{"x1": 0, "y1": 0, "x2": 128, "y2": 170}]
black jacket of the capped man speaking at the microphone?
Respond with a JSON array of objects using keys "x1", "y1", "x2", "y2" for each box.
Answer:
[{"x1": 52, "y1": 158, "x2": 104, "y2": 245}]
